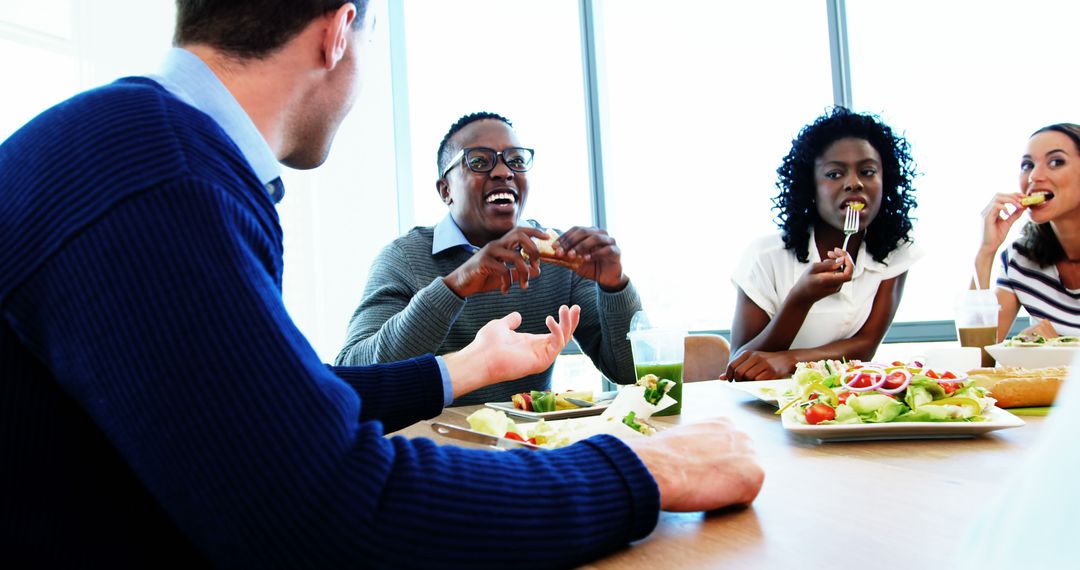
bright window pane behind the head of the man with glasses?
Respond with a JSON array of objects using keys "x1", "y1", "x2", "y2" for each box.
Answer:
[{"x1": 399, "y1": 0, "x2": 592, "y2": 230}]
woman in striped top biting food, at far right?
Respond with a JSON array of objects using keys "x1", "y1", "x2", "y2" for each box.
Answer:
[{"x1": 975, "y1": 123, "x2": 1080, "y2": 340}]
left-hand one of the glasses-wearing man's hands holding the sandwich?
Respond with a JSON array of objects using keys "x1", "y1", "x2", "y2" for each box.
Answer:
[{"x1": 443, "y1": 227, "x2": 546, "y2": 299}]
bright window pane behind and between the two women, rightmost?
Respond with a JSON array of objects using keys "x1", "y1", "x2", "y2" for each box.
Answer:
[{"x1": 847, "y1": 0, "x2": 1080, "y2": 321}]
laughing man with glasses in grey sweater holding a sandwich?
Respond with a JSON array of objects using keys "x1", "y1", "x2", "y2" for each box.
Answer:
[{"x1": 337, "y1": 112, "x2": 642, "y2": 405}]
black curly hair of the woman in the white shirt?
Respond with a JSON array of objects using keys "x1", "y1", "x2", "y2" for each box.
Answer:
[{"x1": 772, "y1": 106, "x2": 917, "y2": 263}]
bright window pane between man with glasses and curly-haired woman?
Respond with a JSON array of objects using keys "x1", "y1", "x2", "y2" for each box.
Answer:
[{"x1": 597, "y1": 0, "x2": 833, "y2": 329}]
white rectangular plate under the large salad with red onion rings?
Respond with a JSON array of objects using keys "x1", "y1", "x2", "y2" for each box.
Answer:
[{"x1": 782, "y1": 406, "x2": 1024, "y2": 442}]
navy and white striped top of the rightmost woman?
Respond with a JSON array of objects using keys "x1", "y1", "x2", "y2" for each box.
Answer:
[{"x1": 998, "y1": 247, "x2": 1080, "y2": 336}]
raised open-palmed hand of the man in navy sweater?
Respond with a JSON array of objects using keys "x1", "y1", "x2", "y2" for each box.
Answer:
[{"x1": 443, "y1": 304, "x2": 581, "y2": 397}]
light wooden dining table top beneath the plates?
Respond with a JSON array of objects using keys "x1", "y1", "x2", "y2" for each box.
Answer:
[{"x1": 388, "y1": 380, "x2": 1045, "y2": 570}]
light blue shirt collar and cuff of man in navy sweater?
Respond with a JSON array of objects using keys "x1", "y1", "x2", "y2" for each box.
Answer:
[{"x1": 148, "y1": 48, "x2": 451, "y2": 407}]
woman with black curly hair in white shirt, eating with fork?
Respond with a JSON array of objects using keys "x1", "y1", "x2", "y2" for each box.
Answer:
[{"x1": 725, "y1": 107, "x2": 921, "y2": 380}]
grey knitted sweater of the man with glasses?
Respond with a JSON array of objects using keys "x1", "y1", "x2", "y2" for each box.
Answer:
[{"x1": 337, "y1": 227, "x2": 642, "y2": 406}]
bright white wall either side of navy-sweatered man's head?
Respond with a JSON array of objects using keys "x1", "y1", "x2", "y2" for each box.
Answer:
[{"x1": 0, "y1": 0, "x2": 397, "y2": 362}]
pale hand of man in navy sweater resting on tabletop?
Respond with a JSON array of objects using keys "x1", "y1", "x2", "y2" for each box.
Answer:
[{"x1": 626, "y1": 418, "x2": 765, "y2": 512}]
